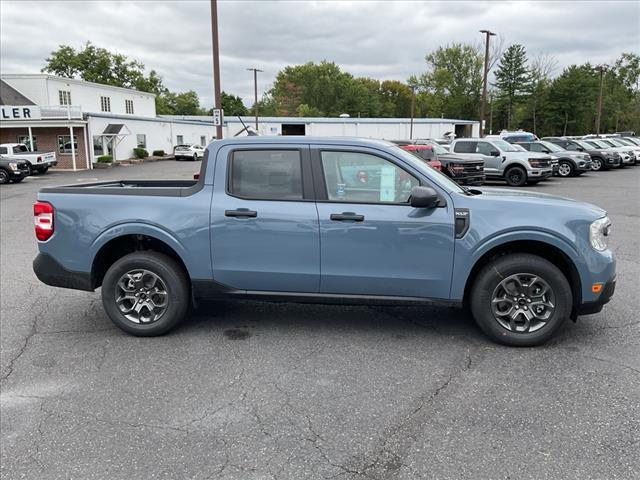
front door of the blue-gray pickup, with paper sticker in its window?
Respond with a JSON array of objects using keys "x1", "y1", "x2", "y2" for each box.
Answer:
[{"x1": 312, "y1": 146, "x2": 454, "y2": 298}]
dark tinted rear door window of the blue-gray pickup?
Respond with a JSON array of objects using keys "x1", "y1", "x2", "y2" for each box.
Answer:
[{"x1": 229, "y1": 150, "x2": 302, "y2": 200}]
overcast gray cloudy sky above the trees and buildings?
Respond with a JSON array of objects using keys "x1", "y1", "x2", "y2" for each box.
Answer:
[{"x1": 0, "y1": 0, "x2": 640, "y2": 107}]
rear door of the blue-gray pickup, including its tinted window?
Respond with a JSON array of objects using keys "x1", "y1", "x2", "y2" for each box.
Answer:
[{"x1": 211, "y1": 144, "x2": 320, "y2": 293}]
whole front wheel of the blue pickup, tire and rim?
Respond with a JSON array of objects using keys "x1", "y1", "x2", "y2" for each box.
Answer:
[{"x1": 470, "y1": 253, "x2": 573, "y2": 347}]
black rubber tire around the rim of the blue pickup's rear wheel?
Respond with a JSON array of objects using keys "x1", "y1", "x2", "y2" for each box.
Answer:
[{"x1": 102, "y1": 251, "x2": 190, "y2": 337}]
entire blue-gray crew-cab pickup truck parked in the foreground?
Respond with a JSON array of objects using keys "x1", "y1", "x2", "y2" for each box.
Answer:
[{"x1": 34, "y1": 137, "x2": 616, "y2": 346}]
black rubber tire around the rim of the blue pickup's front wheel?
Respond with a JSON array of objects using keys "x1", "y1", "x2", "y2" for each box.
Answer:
[{"x1": 469, "y1": 253, "x2": 573, "y2": 347}]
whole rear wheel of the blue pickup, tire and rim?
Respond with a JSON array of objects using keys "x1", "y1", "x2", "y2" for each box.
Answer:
[{"x1": 102, "y1": 251, "x2": 190, "y2": 337}]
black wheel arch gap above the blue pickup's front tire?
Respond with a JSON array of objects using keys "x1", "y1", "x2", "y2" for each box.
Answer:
[{"x1": 462, "y1": 240, "x2": 582, "y2": 316}]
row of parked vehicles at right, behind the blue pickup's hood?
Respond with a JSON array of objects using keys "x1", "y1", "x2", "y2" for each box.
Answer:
[{"x1": 393, "y1": 132, "x2": 640, "y2": 187}]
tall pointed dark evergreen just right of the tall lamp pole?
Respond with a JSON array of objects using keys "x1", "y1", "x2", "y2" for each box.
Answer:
[{"x1": 494, "y1": 43, "x2": 530, "y2": 129}]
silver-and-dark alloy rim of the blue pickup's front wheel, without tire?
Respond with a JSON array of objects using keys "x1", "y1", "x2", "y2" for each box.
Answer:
[{"x1": 491, "y1": 273, "x2": 556, "y2": 333}]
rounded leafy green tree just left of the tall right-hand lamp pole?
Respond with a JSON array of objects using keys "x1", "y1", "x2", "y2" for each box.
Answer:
[{"x1": 417, "y1": 43, "x2": 483, "y2": 119}]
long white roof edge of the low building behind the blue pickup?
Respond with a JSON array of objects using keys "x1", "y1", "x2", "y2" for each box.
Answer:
[{"x1": 158, "y1": 115, "x2": 479, "y2": 125}]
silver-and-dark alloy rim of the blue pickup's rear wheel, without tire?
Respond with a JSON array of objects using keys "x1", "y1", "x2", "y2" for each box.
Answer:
[{"x1": 115, "y1": 270, "x2": 169, "y2": 324}]
